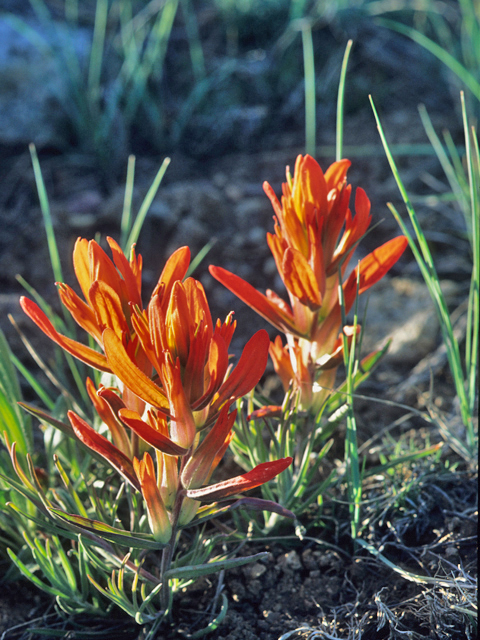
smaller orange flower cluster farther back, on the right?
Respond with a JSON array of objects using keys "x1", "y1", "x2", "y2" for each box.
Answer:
[{"x1": 210, "y1": 155, "x2": 407, "y2": 412}]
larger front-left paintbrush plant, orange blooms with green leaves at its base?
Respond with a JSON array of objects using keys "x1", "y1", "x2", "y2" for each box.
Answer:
[{"x1": 2, "y1": 238, "x2": 293, "y2": 622}]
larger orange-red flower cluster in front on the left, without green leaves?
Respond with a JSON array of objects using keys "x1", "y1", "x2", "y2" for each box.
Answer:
[{"x1": 21, "y1": 238, "x2": 291, "y2": 544}]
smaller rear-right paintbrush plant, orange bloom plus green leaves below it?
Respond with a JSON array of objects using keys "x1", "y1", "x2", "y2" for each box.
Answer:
[{"x1": 210, "y1": 155, "x2": 407, "y2": 531}]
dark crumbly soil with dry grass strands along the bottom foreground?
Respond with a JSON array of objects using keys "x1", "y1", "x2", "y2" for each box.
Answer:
[{"x1": 0, "y1": 469, "x2": 477, "y2": 640}]
